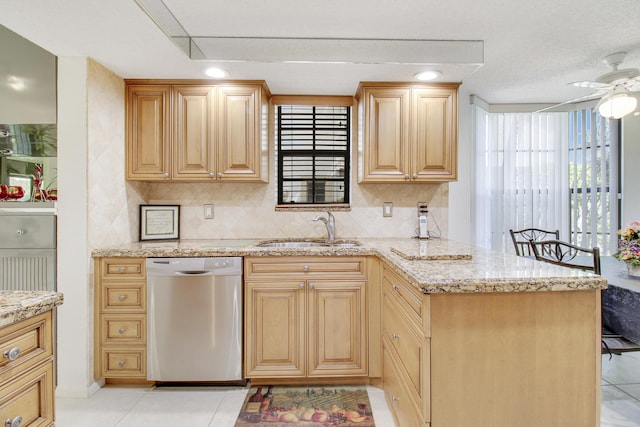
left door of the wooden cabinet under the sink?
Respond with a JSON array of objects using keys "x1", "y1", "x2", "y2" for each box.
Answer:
[{"x1": 245, "y1": 281, "x2": 306, "y2": 378}]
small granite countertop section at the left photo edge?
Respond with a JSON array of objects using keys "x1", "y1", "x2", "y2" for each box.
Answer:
[{"x1": 0, "y1": 291, "x2": 63, "y2": 328}]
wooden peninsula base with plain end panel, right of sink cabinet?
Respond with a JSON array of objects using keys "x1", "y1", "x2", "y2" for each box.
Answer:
[{"x1": 383, "y1": 266, "x2": 601, "y2": 427}]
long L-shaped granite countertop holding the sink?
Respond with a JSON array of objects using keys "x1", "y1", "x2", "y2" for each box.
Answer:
[{"x1": 92, "y1": 238, "x2": 607, "y2": 293}]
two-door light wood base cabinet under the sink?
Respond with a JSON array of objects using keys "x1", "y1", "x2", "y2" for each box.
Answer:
[{"x1": 245, "y1": 257, "x2": 368, "y2": 378}]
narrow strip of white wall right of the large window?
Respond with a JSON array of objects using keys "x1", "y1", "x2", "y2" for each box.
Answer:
[{"x1": 621, "y1": 115, "x2": 640, "y2": 227}]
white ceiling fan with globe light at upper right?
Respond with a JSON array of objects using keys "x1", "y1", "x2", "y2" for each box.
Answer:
[{"x1": 537, "y1": 52, "x2": 640, "y2": 119}]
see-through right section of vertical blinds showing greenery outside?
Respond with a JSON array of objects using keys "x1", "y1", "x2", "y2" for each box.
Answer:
[{"x1": 569, "y1": 109, "x2": 619, "y2": 255}]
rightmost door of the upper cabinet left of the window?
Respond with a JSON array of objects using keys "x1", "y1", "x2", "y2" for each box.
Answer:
[{"x1": 217, "y1": 85, "x2": 266, "y2": 181}]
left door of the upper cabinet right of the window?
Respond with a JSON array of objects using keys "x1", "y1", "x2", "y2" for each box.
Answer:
[{"x1": 360, "y1": 87, "x2": 411, "y2": 182}]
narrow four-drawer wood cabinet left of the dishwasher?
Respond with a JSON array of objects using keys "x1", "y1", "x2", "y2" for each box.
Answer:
[{"x1": 94, "y1": 258, "x2": 147, "y2": 380}]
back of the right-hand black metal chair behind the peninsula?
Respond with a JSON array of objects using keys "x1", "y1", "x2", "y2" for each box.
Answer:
[{"x1": 529, "y1": 240, "x2": 600, "y2": 274}]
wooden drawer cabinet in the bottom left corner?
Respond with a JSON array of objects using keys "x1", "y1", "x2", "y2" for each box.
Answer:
[{"x1": 0, "y1": 311, "x2": 55, "y2": 426}]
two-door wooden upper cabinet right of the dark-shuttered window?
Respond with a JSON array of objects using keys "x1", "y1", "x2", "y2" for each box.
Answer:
[{"x1": 356, "y1": 83, "x2": 459, "y2": 183}]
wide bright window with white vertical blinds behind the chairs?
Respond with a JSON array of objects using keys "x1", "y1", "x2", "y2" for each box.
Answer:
[{"x1": 474, "y1": 105, "x2": 620, "y2": 255}]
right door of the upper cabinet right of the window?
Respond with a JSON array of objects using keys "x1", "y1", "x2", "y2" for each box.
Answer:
[{"x1": 411, "y1": 88, "x2": 457, "y2": 182}]
